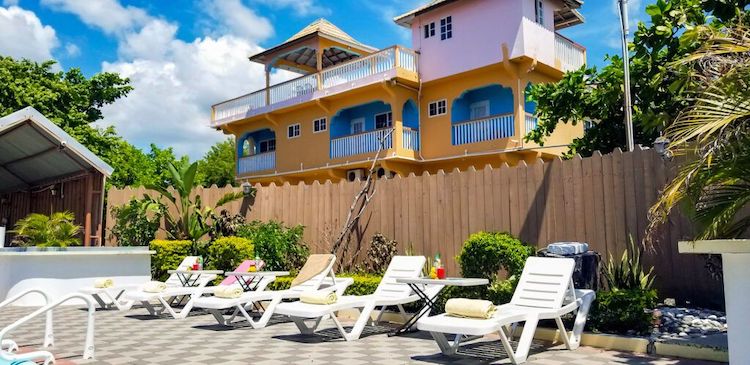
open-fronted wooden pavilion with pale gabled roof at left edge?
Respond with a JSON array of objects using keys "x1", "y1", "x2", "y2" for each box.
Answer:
[{"x1": 0, "y1": 107, "x2": 113, "y2": 246}]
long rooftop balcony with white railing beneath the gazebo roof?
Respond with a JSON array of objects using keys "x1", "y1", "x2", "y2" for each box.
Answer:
[{"x1": 211, "y1": 46, "x2": 418, "y2": 127}]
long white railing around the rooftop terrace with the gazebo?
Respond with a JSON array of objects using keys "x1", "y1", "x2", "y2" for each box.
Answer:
[{"x1": 211, "y1": 47, "x2": 418, "y2": 125}]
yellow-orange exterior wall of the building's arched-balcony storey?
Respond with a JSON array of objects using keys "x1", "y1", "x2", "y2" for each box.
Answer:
[{"x1": 229, "y1": 63, "x2": 583, "y2": 183}]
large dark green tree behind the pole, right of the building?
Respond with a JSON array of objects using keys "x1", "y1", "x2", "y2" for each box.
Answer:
[{"x1": 525, "y1": 0, "x2": 750, "y2": 156}]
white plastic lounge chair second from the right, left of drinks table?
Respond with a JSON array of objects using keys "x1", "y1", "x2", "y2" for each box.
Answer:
[{"x1": 276, "y1": 256, "x2": 432, "y2": 341}]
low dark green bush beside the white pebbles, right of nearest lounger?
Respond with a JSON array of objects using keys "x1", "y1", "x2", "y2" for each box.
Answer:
[{"x1": 587, "y1": 289, "x2": 658, "y2": 334}]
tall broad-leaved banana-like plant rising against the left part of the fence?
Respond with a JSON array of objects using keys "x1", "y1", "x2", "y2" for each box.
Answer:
[{"x1": 146, "y1": 162, "x2": 250, "y2": 242}]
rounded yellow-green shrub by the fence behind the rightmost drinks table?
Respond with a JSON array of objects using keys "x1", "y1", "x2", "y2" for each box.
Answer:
[{"x1": 457, "y1": 232, "x2": 534, "y2": 282}]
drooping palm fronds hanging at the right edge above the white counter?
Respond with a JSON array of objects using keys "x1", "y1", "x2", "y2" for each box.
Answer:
[{"x1": 649, "y1": 21, "x2": 750, "y2": 239}]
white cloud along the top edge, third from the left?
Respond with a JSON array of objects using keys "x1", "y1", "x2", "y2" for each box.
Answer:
[{"x1": 205, "y1": 0, "x2": 273, "y2": 41}]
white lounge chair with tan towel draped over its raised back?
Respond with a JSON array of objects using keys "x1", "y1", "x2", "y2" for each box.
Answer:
[{"x1": 193, "y1": 255, "x2": 354, "y2": 328}]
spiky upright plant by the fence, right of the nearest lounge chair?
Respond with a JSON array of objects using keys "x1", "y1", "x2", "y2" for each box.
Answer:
[{"x1": 602, "y1": 236, "x2": 655, "y2": 290}]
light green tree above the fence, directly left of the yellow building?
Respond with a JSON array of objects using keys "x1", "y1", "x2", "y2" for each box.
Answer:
[{"x1": 196, "y1": 138, "x2": 237, "y2": 187}]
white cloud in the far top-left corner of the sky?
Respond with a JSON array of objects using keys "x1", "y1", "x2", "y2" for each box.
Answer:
[{"x1": 0, "y1": 6, "x2": 59, "y2": 62}]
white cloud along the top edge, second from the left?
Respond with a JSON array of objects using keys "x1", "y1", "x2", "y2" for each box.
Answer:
[{"x1": 41, "y1": 0, "x2": 150, "y2": 34}]
